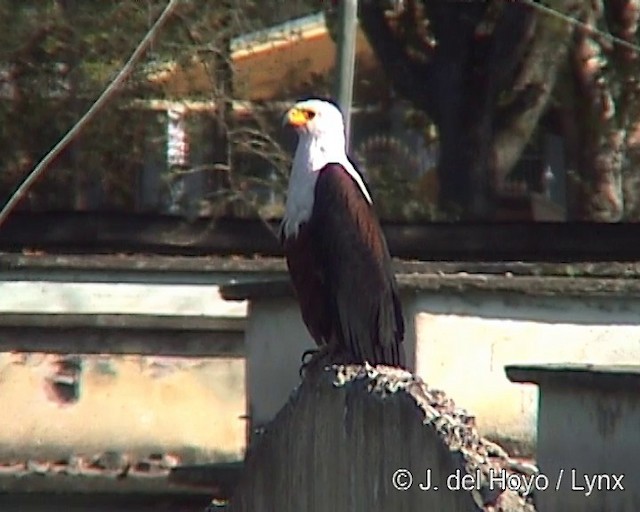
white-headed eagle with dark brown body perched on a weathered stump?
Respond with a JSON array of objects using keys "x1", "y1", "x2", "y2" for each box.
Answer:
[{"x1": 281, "y1": 99, "x2": 404, "y2": 366}]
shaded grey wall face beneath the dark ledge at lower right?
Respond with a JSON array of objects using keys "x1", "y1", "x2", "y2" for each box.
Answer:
[{"x1": 536, "y1": 387, "x2": 640, "y2": 512}]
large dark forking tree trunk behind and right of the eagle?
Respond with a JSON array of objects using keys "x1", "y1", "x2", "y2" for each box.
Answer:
[{"x1": 361, "y1": 0, "x2": 581, "y2": 219}]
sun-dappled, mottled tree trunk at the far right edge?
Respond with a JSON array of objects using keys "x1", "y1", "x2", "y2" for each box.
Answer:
[{"x1": 570, "y1": 0, "x2": 640, "y2": 222}]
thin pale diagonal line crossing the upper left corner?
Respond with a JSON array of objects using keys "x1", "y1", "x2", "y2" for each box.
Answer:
[{"x1": 0, "y1": 0, "x2": 180, "y2": 226}]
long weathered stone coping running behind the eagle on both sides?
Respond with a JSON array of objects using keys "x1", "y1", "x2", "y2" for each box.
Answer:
[{"x1": 5, "y1": 253, "x2": 640, "y2": 300}]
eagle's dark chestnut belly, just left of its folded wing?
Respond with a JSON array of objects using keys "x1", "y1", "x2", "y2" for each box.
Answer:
[{"x1": 283, "y1": 224, "x2": 332, "y2": 346}]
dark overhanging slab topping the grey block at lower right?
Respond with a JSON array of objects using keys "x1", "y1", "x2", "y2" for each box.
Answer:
[{"x1": 505, "y1": 364, "x2": 640, "y2": 390}]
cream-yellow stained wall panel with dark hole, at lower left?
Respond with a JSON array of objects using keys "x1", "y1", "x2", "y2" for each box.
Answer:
[{"x1": 0, "y1": 353, "x2": 246, "y2": 463}]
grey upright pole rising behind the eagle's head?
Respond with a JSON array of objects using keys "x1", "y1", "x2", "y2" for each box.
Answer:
[{"x1": 336, "y1": 0, "x2": 358, "y2": 151}]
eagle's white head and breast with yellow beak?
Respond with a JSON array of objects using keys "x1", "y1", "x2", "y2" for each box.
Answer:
[{"x1": 282, "y1": 99, "x2": 371, "y2": 237}]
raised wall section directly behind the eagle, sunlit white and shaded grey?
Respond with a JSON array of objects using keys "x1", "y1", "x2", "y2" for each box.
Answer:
[{"x1": 246, "y1": 291, "x2": 640, "y2": 453}]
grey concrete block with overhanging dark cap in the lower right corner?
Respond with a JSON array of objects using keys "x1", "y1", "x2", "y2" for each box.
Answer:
[{"x1": 506, "y1": 361, "x2": 640, "y2": 512}]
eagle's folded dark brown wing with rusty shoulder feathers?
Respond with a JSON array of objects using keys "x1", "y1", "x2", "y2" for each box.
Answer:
[{"x1": 309, "y1": 164, "x2": 404, "y2": 366}]
